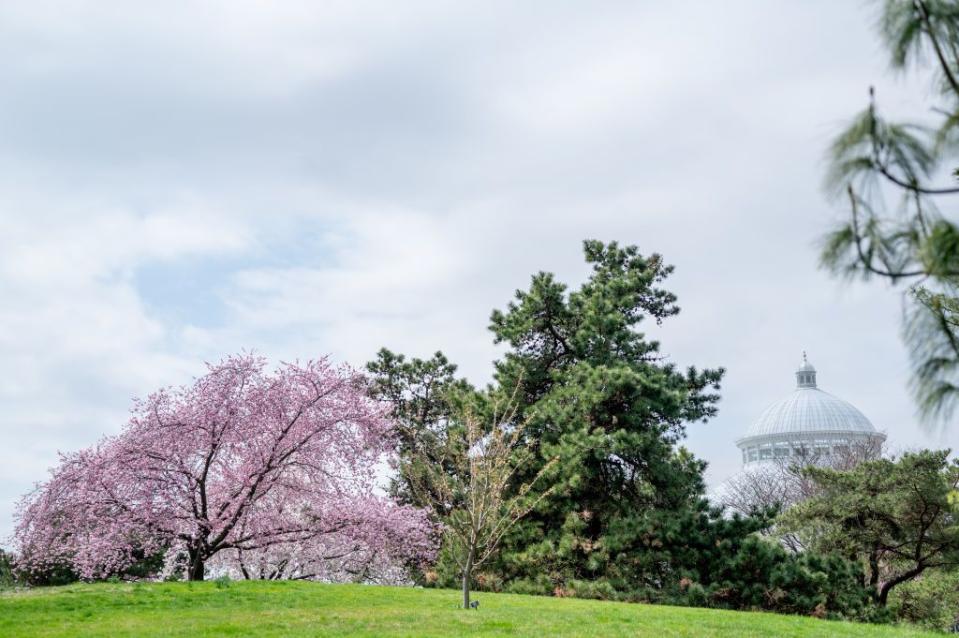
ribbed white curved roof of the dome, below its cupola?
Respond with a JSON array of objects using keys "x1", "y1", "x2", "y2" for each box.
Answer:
[{"x1": 743, "y1": 387, "x2": 876, "y2": 439}]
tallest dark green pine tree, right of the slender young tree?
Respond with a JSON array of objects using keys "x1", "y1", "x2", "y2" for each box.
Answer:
[{"x1": 490, "y1": 241, "x2": 723, "y2": 591}]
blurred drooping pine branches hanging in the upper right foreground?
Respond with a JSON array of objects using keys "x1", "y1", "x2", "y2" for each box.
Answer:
[{"x1": 820, "y1": 0, "x2": 959, "y2": 430}]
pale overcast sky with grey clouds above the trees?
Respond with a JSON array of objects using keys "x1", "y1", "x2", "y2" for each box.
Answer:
[{"x1": 0, "y1": 0, "x2": 959, "y2": 538}]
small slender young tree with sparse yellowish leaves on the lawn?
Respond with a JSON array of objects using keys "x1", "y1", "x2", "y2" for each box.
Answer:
[{"x1": 406, "y1": 399, "x2": 555, "y2": 609}]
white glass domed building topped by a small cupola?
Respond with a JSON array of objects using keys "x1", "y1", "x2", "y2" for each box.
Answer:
[{"x1": 736, "y1": 352, "x2": 886, "y2": 467}]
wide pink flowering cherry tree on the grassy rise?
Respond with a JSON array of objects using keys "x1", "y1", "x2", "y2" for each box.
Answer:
[{"x1": 14, "y1": 355, "x2": 434, "y2": 580}]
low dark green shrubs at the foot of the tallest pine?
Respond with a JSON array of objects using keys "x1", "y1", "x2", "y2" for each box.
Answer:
[{"x1": 508, "y1": 506, "x2": 889, "y2": 621}]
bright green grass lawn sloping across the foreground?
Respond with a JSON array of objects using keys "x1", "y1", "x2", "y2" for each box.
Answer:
[{"x1": 0, "y1": 582, "x2": 936, "y2": 638}]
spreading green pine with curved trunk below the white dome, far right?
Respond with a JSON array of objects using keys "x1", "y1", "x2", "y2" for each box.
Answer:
[{"x1": 781, "y1": 451, "x2": 959, "y2": 605}]
